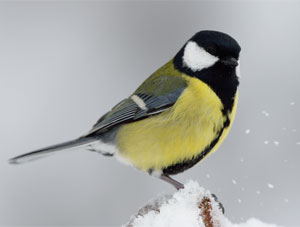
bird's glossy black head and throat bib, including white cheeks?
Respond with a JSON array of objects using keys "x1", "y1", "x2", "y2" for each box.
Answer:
[{"x1": 173, "y1": 31, "x2": 241, "y2": 113}]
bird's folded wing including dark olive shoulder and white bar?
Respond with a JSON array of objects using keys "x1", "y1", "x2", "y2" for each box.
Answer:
[{"x1": 84, "y1": 76, "x2": 186, "y2": 136}]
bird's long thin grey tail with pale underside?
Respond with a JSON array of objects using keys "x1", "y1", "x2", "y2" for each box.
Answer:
[{"x1": 9, "y1": 137, "x2": 97, "y2": 164}]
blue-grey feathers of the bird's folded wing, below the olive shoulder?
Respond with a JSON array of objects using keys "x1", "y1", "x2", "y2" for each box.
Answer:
[{"x1": 84, "y1": 88, "x2": 185, "y2": 136}]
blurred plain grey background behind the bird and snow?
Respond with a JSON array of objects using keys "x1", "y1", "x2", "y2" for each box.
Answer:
[{"x1": 0, "y1": 1, "x2": 300, "y2": 226}]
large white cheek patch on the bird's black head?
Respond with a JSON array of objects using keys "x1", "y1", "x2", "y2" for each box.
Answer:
[{"x1": 182, "y1": 41, "x2": 219, "y2": 72}]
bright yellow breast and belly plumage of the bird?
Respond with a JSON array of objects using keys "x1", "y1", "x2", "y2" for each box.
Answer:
[{"x1": 117, "y1": 76, "x2": 235, "y2": 171}]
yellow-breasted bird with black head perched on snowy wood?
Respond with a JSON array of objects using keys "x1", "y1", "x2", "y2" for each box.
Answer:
[{"x1": 9, "y1": 30, "x2": 241, "y2": 189}]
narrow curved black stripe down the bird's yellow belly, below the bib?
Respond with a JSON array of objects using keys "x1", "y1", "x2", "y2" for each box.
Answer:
[{"x1": 163, "y1": 116, "x2": 230, "y2": 175}]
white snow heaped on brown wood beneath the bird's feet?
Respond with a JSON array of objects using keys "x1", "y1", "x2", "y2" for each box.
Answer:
[{"x1": 124, "y1": 181, "x2": 284, "y2": 227}]
